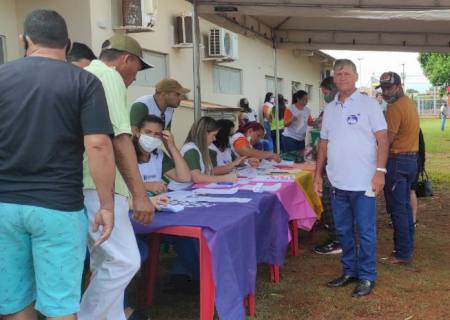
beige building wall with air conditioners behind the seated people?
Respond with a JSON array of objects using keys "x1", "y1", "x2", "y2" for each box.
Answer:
[{"x1": 86, "y1": 0, "x2": 321, "y2": 144}]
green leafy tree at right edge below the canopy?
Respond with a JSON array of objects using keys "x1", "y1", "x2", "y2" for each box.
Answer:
[{"x1": 418, "y1": 53, "x2": 450, "y2": 96}]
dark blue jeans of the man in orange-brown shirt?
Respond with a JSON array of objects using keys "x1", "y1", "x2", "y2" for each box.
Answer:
[{"x1": 384, "y1": 154, "x2": 417, "y2": 260}]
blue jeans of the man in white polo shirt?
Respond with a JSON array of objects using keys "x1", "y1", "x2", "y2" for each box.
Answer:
[{"x1": 331, "y1": 188, "x2": 377, "y2": 281}]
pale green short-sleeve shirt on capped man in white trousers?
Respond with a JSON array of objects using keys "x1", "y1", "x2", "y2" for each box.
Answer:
[{"x1": 83, "y1": 60, "x2": 131, "y2": 197}]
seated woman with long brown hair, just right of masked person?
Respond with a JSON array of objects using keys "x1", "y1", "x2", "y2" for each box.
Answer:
[{"x1": 169, "y1": 117, "x2": 237, "y2": 190}]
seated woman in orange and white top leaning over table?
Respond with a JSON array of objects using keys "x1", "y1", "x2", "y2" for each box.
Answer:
[{"x1": 230, "y1": 122, "x2": 281, "y2": 162}]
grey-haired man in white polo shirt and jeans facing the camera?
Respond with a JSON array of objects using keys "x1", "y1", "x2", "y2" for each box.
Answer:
[{"x1": 314, "y1": 59, "x2": 388, "y2": 297}]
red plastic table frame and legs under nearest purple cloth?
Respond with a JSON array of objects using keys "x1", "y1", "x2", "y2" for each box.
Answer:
[{"x1": 144, "y1": 226, "x2": 255, "y2": 320}]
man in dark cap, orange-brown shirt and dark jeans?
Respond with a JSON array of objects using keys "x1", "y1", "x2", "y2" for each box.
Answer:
[{"x1": 378, "y1": 72, "x2": 420, "y2": 265}]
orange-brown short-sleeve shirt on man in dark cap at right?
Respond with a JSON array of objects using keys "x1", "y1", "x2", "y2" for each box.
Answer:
[{"x1": 386, "y1": 96, "x2": 420, "y2": 153}]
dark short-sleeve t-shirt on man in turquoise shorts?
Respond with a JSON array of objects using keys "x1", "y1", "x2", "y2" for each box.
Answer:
[{"x1": 0, "y1": 57, "x2": 113, "y2": 211}]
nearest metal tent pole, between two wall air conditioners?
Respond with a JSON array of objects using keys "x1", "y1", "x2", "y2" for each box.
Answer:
[{"x1": 192, "y1": 0, "x2": 202, "y2": 121}]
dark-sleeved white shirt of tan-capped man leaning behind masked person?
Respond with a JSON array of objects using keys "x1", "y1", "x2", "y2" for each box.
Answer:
[{"x1": 130, "y1": 95, "x2": 175, "y2": 129}]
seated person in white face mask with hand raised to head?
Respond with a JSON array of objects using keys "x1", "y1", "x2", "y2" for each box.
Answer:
[{"x1": 133, "y1": 115, "x2": 191, "y2": 194}]
